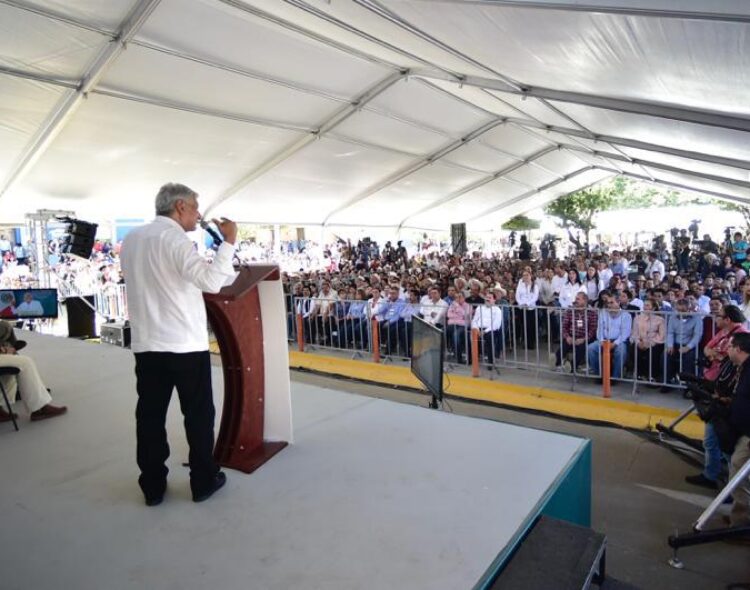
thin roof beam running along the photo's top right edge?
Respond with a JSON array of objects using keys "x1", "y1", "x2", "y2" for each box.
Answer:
[{"x1": 406, "y1": 0, "x2": 750, "y2": 23}]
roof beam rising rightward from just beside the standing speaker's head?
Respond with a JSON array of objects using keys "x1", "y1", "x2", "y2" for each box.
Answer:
[{"x1": 204, "y1": 70, "x2": 408, "y2": 215}]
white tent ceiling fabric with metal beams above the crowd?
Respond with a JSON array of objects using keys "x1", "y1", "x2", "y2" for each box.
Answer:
[{"x1": 0, "y1": 0, "x2": 750, "y2": 231}]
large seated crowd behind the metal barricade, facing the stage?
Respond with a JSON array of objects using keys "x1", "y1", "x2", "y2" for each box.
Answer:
[{"x1": 283, "y1": 230, "x2": 750, "y2": 392}]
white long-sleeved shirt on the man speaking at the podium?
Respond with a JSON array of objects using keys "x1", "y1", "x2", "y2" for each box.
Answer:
[{"x1": 120, "y1": 215, "x2": 235, "y2": 353}]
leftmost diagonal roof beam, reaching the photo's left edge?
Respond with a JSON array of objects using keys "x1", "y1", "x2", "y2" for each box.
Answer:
[{"x1": 0, "y1": 0, "x2": 160, "y2": 198}]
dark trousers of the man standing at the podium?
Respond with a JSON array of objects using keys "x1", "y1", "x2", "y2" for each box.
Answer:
[{"x1": 135, "y1": 350, "x2": 219, "y2": 497}]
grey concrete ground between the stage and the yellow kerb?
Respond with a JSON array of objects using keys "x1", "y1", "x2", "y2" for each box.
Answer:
[{"x1": 292, "y1": 371, "x2": 750, "y2": 590}]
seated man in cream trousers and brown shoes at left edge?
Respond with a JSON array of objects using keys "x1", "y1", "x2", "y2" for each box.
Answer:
[{"x1": 0, "y1": 320, "x2": 68, "y2": 422}]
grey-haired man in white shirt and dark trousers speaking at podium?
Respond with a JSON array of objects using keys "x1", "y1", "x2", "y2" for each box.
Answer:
[{"x1": 121, "y1": 183, "x2": 237, "y2": 506}]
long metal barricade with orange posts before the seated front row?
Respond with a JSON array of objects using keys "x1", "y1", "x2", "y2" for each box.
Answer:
[{"x1": 294, "y1": 298, "x2": 713, "y2": 395}]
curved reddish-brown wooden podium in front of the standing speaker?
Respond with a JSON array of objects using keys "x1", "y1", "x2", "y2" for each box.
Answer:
[{"x1": 203, "y1": 265, "x2": 291, "y2": 473}]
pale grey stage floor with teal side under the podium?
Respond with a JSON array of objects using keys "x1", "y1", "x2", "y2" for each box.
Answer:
[{"x1": 0, "y1": 334, "x2": 591, "y2": 590}]
